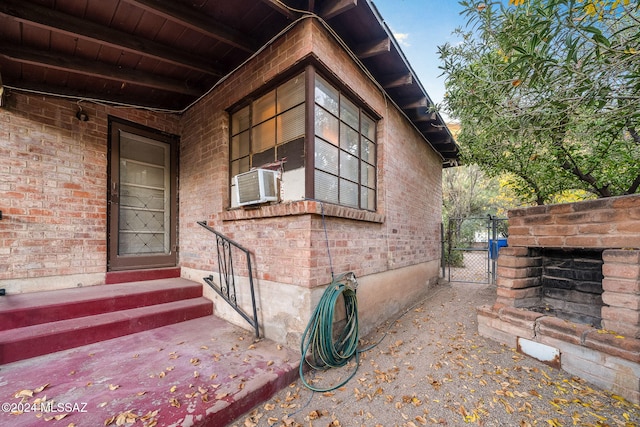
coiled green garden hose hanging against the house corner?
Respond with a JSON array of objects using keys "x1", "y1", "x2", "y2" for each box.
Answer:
[{"x1": 300, "y1": 272, "x2": 360, "y2": 392}]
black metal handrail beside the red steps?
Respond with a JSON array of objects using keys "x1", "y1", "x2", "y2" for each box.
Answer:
[{"x1": 198, "y1": 221, "x2": 260, "y2": 338}]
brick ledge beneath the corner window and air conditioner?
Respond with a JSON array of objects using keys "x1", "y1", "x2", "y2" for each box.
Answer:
[{"x1": 220, "y1": 200, "x2": 384, "y2": 224}]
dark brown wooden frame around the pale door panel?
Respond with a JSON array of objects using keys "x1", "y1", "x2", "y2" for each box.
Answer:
[{"x1": 107, "y1": 116, "x2": 180, "y2": 271}]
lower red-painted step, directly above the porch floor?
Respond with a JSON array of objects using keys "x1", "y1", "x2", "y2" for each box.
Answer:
[{"x1": 0, "y1": 297, "x2": 213, "y2": 364}]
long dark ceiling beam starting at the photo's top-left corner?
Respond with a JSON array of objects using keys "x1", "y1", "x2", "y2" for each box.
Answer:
[{"x1": 0, "y1": 0, "x2": 224, "y2": 76}]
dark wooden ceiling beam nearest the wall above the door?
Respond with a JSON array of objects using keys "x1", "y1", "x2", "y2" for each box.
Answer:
[{"x1": 0, "y1": 44, "x2": 202, "y2": 96}]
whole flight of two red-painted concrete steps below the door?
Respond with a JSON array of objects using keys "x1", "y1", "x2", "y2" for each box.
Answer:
[{"x1": 0, "y1": 278, "x2": 213, "y2": 364}]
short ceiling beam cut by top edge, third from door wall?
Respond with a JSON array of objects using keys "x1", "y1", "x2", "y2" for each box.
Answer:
[{"x1": 123, "y1": 0, "x2": 258, "y2": 53}]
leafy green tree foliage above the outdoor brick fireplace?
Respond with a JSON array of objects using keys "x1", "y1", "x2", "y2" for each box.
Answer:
[{"x1": 439, "y1": 0, "x2": 640, "y2": 204}]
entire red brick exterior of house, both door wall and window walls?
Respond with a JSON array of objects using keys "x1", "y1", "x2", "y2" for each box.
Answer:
[{"x1": 0, "y1": 19, "x2": 442, "y2": 296}]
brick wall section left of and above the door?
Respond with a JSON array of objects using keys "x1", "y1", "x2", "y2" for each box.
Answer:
[{"x1": 0, "y1": 92, "x2": 179, "y2": 292}]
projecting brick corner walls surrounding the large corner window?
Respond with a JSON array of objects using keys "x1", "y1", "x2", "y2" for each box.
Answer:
[{"x1": 180, "y1": 20, "x2": 442, "y2": 287}]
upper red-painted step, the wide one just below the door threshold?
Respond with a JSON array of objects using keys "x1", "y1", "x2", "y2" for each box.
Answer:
[{"x1": 0, "y1": 279, "x2": 202, "y2": 331}]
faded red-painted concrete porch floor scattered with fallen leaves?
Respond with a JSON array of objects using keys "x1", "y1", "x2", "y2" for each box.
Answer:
[{"x1": 0, "y1": 316, "x2": 299, "y2": 427}]
